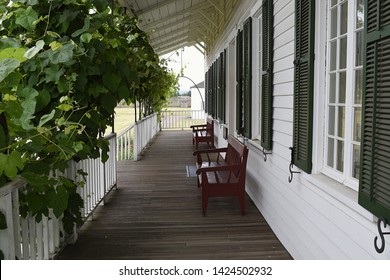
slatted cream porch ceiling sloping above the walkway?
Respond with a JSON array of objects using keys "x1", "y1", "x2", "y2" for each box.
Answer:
[{"x1": 119, "y1": 0, "x2": 239, "y2": 55}]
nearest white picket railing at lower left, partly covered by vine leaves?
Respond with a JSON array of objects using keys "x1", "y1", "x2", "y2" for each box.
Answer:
[{"x1": 0, "y1": 133, "x2": 117, "y2": 260}]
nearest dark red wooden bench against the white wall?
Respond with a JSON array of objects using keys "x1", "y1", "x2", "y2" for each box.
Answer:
[{"x1": 194, "y1": 135, "x2": 248, "y2": 216}]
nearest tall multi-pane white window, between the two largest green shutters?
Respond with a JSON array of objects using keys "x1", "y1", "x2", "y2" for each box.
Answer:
[{"x1": 323, "y1": 0, "x2": 364, "y2": 190}]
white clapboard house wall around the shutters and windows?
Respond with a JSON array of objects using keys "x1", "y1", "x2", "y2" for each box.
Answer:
[{"x1": 206, "y1": 0, "x2": 390, "y2": 259}]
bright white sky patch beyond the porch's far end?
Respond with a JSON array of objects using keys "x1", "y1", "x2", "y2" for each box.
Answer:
[{"x1": 162, "y1": 47, "x2": 204, "y2": 90}]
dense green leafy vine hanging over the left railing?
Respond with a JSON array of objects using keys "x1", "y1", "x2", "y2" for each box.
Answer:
[{"x1": 0, "y1": 0, "x2": 177, "y2": 232}]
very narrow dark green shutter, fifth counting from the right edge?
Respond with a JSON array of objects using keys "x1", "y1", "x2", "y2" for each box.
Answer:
[{"x1": 236, "y1": 30, "x2": 243, "y2": 134}]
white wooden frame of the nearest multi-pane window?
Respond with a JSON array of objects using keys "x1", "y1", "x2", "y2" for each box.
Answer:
[{"x1": 313, "y1": 0, "x2": 359, "y2": 191}]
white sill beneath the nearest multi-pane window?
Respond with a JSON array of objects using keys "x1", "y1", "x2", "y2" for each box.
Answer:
[{"x1": 302, "y1": 173, "x2": 376, "y2": 222}]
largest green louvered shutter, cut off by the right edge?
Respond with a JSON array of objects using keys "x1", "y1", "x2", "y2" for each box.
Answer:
[{"x1": 359, "y1": 1, "x2": 390, "y2": 223}]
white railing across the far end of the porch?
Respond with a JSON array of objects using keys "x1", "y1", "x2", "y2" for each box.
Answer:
[{"x1": 161, "y1": 110, "x2": 206, "y2": 130}]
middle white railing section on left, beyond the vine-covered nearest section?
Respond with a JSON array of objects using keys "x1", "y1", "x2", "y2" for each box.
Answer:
[{"x1": 117, "y1": 111, "x2": 160, "y2": 160}]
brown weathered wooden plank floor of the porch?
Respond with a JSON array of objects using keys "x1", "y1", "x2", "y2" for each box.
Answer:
[{"x1": 57, "y1": 131, "x2": 291, "y2": 260}]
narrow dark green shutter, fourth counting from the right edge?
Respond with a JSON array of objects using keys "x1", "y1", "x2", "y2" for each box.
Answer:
[{"x1": 242, "y1": 17, "x2": 252, "y2": 138}]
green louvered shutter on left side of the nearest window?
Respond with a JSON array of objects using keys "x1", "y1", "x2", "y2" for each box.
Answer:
[{"x1": 293, "y1": 0, "x2": 315, "y2": 173}]
